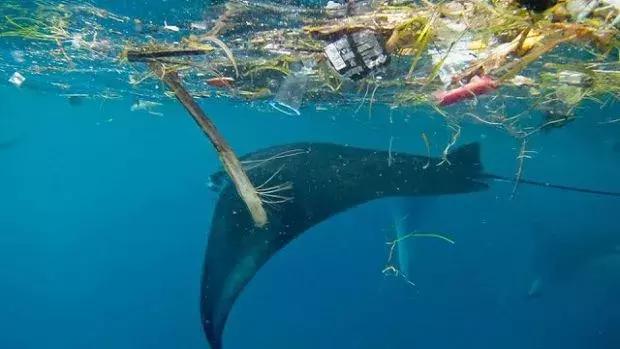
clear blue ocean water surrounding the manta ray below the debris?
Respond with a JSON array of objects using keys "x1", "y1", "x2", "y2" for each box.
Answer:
[{"x1": 0, "y1": 2, "x2": 620, "y2": 349}]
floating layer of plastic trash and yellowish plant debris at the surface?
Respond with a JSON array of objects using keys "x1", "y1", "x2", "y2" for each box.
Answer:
[{"x1": 0, "y1": 0, "x2": 620, "y2": 123}]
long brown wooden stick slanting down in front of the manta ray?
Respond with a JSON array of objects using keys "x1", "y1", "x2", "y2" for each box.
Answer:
[{"x1": 149, "y1": 62, "x2": 267, "y2": 227}]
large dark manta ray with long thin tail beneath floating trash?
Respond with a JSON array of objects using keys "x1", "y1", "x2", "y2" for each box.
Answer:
[{"x1": 200, "y1": 143, "x2": 620, "y2": 349}]
